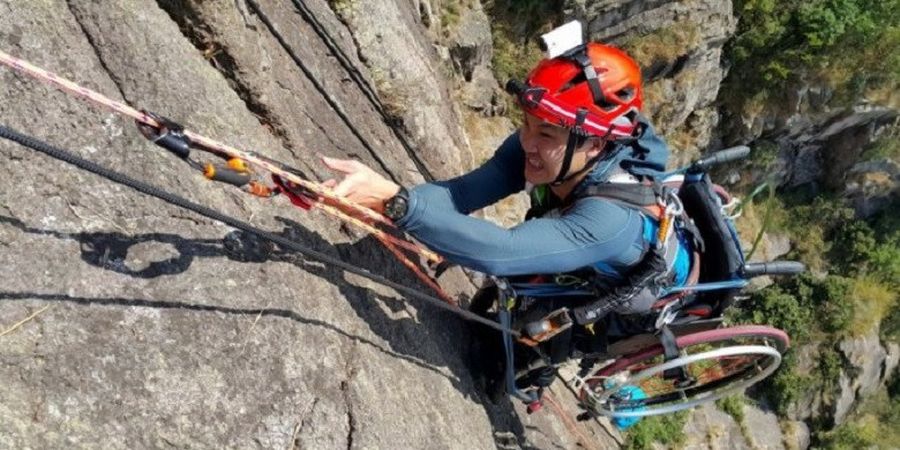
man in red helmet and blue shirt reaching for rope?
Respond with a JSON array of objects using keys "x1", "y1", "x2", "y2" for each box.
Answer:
[{"x1": 323, "y1": 43, "x2": 689, "y2": 402}]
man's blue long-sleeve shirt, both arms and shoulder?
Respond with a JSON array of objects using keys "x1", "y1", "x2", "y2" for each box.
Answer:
[{"x1": 397, "y1": 116, "x2": 668, "y2": 276}]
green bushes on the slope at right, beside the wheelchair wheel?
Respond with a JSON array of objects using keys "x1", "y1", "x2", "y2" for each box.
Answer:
[{"x1": 729, "y1": 192, "x2": 900, "y2": 416}]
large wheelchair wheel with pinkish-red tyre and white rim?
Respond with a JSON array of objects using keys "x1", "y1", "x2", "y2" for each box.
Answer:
[{"x1": 579, "y1": 325, "x2": 789, "y2": 417}]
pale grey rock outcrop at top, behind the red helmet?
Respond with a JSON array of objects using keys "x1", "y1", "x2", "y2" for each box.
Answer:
[{"x1": 565, "y1": 0, "x2": 737, "y2": 165}]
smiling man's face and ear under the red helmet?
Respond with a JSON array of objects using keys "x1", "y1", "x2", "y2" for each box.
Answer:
[{"x1": 519, "y1": 114, "x2": 599, "y2": 185}]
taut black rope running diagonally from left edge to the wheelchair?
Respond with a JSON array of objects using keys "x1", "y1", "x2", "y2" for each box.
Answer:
[{"x1": 0, "y1": 125, "x2": 519, "y2": 336}]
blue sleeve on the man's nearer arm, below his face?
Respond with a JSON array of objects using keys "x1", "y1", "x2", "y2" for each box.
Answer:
[{"x1": 398, "y1": 194, "x2": 643, "y2": 276}]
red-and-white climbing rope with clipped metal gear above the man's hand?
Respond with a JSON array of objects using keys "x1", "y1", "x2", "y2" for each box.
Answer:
[{"x1": 0, "y1": 51, "x2": 457, "y2": 305}]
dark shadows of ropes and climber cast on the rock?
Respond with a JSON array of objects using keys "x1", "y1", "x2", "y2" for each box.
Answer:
[{"x1": 0, "y1": 215, "x2": 533, "y2": 449}]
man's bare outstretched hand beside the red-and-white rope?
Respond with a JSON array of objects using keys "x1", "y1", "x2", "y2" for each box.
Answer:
[{"x1": 322, "y1": 156, "x2": 400, "y2": 212}]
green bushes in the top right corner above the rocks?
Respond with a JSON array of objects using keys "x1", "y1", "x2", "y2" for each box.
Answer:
[{"x1": 728, "y1": 0, "x2": 900, "y2": 107}]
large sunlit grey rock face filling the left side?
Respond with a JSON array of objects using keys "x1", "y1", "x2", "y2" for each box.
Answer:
[{"x1": 0, "y1": 0, "x2": 601, "y2": 448}]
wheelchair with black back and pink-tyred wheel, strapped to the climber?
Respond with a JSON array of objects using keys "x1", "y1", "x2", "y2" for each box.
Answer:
[{"x1": 470, "y1": 147, "x2": 805, "y2": 419}]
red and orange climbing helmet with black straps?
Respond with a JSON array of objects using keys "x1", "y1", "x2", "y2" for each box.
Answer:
[{"x1": 507, "y1": 42, "x2": 642, "y2": 139}]
